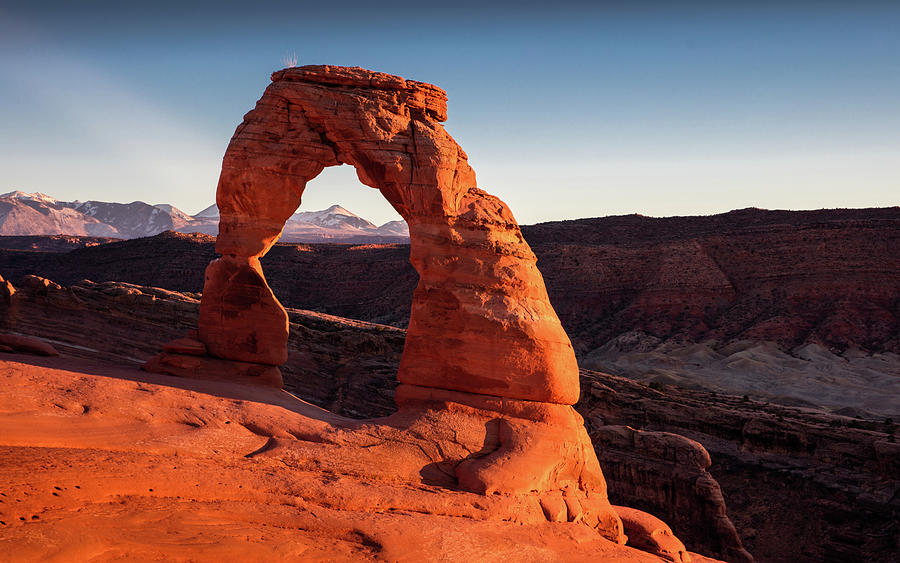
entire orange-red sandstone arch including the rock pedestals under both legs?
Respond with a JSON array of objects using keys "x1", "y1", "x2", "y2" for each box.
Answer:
[{"x1": 146, "y1": 66, "x2": 644, "y2": 543}]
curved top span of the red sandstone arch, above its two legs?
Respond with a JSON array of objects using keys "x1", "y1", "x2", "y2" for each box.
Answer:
[{"x1": 216, "y1": 66, "x2": 476, "y2": 256}]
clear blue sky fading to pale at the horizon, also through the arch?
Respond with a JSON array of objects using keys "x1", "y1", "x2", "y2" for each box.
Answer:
[{"x1": 0, "y1": 0, "x2": 900, "y2": 223}]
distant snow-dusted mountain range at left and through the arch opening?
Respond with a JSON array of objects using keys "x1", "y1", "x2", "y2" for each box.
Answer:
[{"x1": 0, "y1": 191, "x2": 409, "y2": 243}]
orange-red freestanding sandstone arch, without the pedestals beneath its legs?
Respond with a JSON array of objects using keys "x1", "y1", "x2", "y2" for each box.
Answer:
[{"x1": 199, "y1": 66, "x2": 579, "y2": 405}]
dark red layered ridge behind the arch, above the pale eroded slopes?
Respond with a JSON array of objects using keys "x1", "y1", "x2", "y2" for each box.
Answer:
[{"x1": 0, "y1": 208, "x2": 900, "y2": 355}]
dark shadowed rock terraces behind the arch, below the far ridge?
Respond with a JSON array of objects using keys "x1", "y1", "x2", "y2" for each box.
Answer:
[{"x1": 0, "y1": 282, "x2": 900, "y2": 563}]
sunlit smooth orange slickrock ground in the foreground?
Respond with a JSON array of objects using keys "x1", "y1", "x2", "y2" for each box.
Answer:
[{"x1": 0, "y1": 355, "x2": 707, "y2": 563}]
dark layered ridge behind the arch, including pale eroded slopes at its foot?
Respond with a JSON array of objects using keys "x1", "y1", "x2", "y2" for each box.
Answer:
[{"x1": 0, "y1": 208, "x2": 900, "y2": 419}]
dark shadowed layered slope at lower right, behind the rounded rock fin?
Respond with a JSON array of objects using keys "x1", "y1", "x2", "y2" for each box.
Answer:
[{"x1": 579, "y1": 371, "x2": 900, "y2": 563}]
